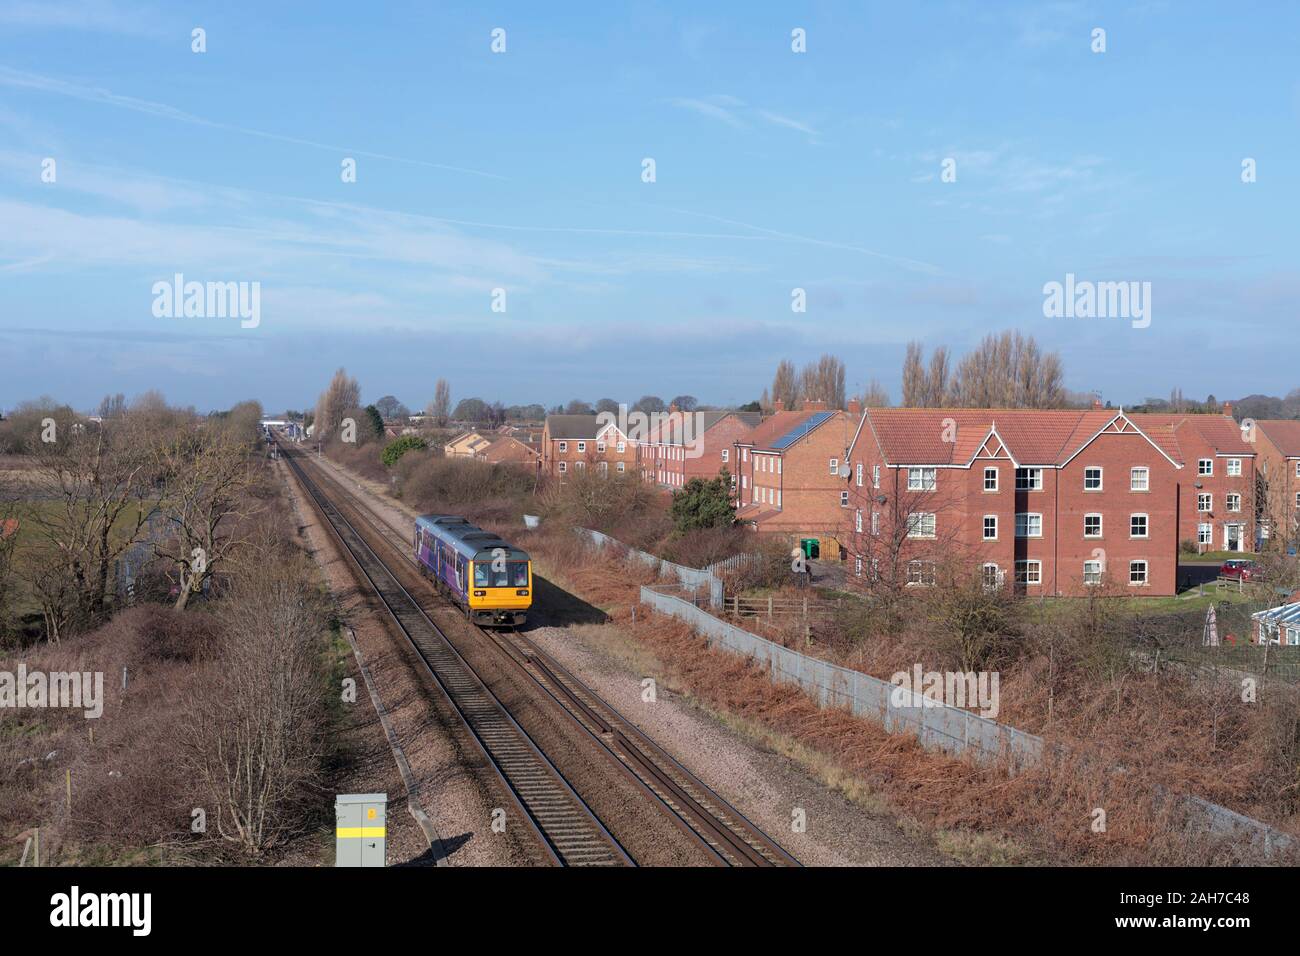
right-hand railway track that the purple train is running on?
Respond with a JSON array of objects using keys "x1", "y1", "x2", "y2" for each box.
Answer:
[{"x1": 280, "y1": 442, "x2": 800, "y2": 866}]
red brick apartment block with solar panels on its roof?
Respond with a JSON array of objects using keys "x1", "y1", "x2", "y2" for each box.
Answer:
[{"x1": 733, "y1": 402, "x2": 858, "y2": 561}]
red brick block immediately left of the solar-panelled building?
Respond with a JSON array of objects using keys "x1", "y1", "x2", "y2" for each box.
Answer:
[{"x1": 637, "y1": 410, "x2": 762, "y2": 489}]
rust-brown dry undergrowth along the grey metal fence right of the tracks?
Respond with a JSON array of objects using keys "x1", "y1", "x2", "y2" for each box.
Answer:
[{"x1": 534, "y1": 537, "x2": 1300, "y2": 865}]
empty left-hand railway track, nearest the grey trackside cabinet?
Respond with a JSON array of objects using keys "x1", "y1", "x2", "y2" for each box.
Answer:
[{"x1": 281, "y1": 446, "x2": 634, "y2": 866}]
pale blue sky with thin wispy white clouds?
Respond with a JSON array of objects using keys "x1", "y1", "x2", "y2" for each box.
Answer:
[{"x1": 0, "y1": 0, "x2": 1300, "y2": 411}]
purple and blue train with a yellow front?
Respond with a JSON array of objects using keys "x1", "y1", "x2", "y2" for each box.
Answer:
[{"x1": 415, "y1": 515, "x2": 533, "y2": 627}]
